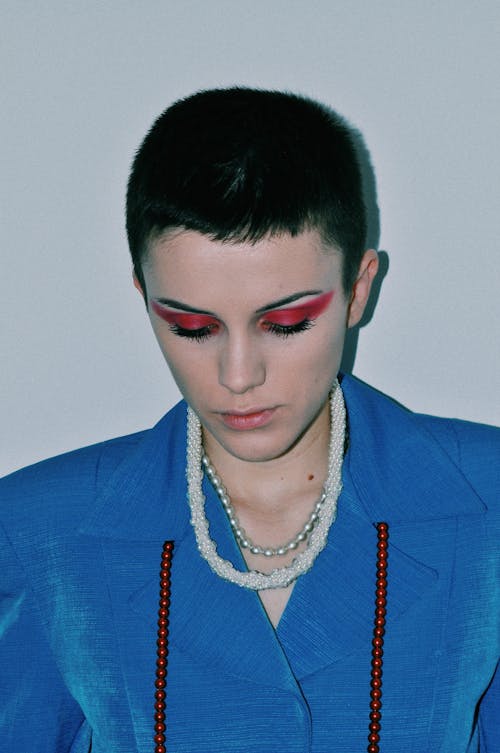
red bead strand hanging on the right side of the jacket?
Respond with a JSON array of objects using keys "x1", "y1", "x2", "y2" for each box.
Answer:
[{"x1": 367, "y1": 523, "x2": 389, "y2": 753}]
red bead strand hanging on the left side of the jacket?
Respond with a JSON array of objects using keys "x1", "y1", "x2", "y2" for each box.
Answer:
[{"x1": 154, "y1": 541, "x2": 174, "y2": 753}]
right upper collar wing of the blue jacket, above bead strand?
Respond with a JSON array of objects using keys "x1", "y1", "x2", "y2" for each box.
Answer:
[{"x1": 342, "y1": 377, "x2": 486, "y2": 523}]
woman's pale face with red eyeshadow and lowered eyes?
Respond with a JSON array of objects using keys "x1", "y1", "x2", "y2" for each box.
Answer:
[{"x1": 136, "y1": 231, "x2": 376, "y2": 462}]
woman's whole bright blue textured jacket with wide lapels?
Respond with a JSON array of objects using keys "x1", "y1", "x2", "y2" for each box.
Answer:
[{"x1": 0, "y1": 377, "x2": 500, "y2": 753}]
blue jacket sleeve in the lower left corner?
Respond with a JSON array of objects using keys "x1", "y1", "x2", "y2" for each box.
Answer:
[{"x1": 0, "y1": 527, "x2": 88, "y2": 753}]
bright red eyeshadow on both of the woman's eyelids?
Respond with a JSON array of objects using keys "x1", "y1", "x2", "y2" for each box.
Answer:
[{"x1": 151, "y1": 290, "x2": 334, "y2": 332}]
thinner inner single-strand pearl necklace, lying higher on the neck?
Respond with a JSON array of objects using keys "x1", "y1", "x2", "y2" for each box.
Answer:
[{"x1": 202, "y1": 455, "x2": 326, "y2": 557}]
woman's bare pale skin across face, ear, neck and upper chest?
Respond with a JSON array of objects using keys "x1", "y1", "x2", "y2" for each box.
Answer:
[{"x1": 135, "y1": 230, "x2": 377, "y2": 624}]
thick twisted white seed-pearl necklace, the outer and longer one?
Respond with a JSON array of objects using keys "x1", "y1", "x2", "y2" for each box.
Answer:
[{"x1": 186, "y1": 382, "x2": 346, "y2": 591}]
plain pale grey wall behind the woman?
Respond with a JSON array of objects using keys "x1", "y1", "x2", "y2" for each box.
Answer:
[{"x1": 0, "y1": 0, "x2": 500, "y2": 474}]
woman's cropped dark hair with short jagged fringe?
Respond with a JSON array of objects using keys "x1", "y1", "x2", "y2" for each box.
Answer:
[{"x1": 127, "y1": 87, "x2": 367, "y2": 293}]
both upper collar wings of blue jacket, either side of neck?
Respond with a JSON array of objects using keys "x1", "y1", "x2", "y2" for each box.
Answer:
[{"x1": 80, "y1": 376, "x2": 485, "y2": 541}]
